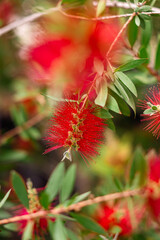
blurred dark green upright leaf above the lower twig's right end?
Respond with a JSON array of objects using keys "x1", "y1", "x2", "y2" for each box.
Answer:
[{"x1": 130, "y1": 147, "x2": 147, "y2": 185}]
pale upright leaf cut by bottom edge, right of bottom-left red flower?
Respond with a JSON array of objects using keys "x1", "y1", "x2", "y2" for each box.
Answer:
[{"x1": 53, "y1": 217, "x2": 67, "y2": 240}]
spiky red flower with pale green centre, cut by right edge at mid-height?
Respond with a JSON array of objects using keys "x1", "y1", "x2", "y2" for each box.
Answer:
[{"x1": 139, "y1": 86, "x2": 160, "y2": 139}]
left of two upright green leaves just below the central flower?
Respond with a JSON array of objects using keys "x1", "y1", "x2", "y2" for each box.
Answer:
[{"x1": 43, "y1": 162, "x2": 64, "y2": 207}]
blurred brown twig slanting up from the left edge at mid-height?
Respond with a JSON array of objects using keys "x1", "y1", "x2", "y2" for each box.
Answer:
[{"x1": 0, "y1": 113, "x2": 46, "y2": 145}]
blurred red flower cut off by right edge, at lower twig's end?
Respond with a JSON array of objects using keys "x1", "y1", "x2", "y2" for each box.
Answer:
[{"x1": 147, "y1": 152, "x2": 160, "y2": 223}]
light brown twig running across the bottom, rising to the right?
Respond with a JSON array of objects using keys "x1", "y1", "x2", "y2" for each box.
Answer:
[{"x1": 0, "y1": 189, "x2": 142, "y2": 225}]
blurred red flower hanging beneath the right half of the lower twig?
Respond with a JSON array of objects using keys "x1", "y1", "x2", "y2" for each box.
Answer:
[{"x1": 95, "y1": 202, "x2": 144, "y2": 236}]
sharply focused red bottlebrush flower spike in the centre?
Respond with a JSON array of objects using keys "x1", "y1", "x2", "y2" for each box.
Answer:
[{"x1": 44, "y1": 102, "x2": 105, "y2": 161}]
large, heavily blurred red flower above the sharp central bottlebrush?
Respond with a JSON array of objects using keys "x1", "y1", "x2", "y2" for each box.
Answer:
[{"x1": 22, "y1": 21, "x2": 122, "y2": 94}]
